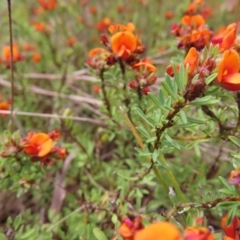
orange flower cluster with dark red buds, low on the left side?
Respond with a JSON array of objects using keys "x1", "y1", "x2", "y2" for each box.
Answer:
[{"x1": 1, "y1": 130, "x2": 67, "y2": 166}]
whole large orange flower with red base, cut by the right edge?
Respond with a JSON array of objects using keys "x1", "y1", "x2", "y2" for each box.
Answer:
[{"x1": 217, "y1": 49, "x2": 240, "y2": 91}]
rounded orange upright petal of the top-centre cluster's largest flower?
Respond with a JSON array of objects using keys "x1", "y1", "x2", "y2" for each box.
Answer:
[{"x1": 111, "y1": 31, "x2": 137, "y2": 54}]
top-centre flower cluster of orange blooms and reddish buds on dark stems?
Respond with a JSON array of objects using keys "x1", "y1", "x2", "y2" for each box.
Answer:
[{"x1": 86, "y1": 23, "x2": 157, "y2": 96}]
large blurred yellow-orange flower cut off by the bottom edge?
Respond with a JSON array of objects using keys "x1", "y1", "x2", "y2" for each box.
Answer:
[{"x1": 134, "y1": 222, "x2": 182, "y2": 240}]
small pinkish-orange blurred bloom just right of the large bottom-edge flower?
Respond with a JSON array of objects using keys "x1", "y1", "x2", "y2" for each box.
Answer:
[{"x1": 184, "y1": 227, "x2": 214, "y2": 240}]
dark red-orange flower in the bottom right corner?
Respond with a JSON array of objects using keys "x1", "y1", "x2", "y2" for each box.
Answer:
[{"x1": 221, "y1": 215, "x2": 240, "y2": 240}]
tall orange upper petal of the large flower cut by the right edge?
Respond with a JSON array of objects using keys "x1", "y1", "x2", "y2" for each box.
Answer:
[{"x1": 217, "y1": 49, "x2": 240, "y2": 82}]
